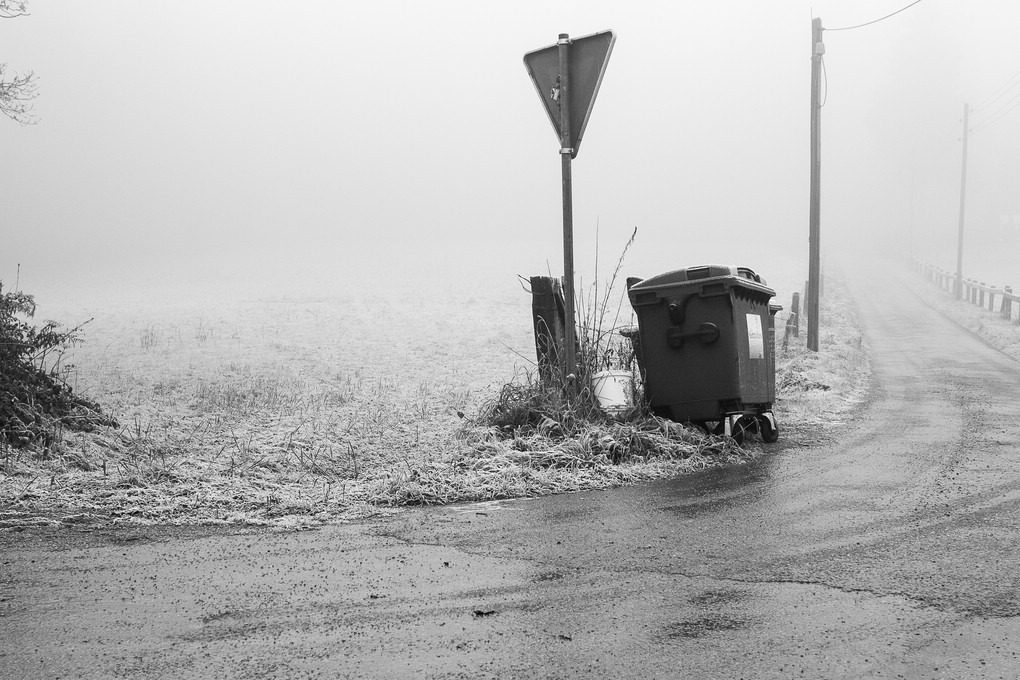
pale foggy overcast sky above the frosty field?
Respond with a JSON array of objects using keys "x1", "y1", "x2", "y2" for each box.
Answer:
[{"x1": 0, "y1": 0, "x2": 1020, "y2": 303}]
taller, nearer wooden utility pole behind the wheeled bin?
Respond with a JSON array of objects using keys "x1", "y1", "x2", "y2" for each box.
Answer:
[{"x1": 807, "y1": 18, "x2": 825, "y2": 352}]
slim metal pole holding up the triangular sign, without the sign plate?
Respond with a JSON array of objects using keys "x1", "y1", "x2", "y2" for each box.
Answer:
[{"x1": 556, "y1": 33, "x2": 577, "y2": 393}]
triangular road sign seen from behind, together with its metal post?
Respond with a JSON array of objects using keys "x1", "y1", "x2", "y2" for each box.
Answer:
[{"x1": 524, "y1": 31, "x2": 616, "y2": 389}]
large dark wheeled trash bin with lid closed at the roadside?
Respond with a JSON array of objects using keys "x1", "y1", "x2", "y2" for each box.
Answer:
[{"x1": 627, "y1": 265, "x2": 782, "y2": 442}]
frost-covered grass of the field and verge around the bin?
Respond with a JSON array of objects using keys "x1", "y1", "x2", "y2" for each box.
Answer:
[{"x1": 0, "y1": 273, "x2": 867, "y2": 527}]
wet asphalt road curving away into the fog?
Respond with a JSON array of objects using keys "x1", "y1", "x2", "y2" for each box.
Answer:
[{"x1": 0, "y1": 273, "x2": 1020, "y2": 679}]
